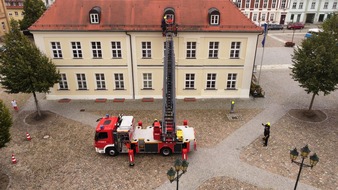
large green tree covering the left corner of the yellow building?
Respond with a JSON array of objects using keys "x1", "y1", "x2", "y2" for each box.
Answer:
[{"x1": 0, "y1": 20, "x2": 60, "y2": 116}]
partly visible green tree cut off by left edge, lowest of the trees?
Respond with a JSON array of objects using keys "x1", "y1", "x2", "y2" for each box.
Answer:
[{"x1": 0, "y1": 100, "x2": 13, "y2": 148}]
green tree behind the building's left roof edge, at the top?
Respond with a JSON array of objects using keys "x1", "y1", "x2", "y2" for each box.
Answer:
[{"x1": 20, "y1": 0, "x2": 46, "y2": 30}]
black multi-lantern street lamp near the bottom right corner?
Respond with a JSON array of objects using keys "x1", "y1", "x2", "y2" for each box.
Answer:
[{"x1": 290, "y1": 145, "x2": 319, "y2": 190}]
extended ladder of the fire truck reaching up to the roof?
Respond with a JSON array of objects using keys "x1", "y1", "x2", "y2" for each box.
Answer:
[{"x1": 162, "y1": 24, "x2": 177, "y2": 142}]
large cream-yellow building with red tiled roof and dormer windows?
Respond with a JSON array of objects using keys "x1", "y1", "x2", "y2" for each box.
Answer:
[{"x1": 29, "y1": 0, "x2": 262, "y2": 99}]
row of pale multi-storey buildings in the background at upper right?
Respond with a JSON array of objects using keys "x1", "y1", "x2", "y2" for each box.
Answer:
[{"x1": 233, "y1": 0, "x2": 337, "y2": 25}]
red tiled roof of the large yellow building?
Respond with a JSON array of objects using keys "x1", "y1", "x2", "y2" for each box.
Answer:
[{"x1": 29, "y1": 0, "x2": 262, "y2": 32}]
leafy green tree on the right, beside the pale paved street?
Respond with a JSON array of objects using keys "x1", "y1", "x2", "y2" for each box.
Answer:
[{"x1": 291, "y1": 14, "x2": 338, "y2": 110}]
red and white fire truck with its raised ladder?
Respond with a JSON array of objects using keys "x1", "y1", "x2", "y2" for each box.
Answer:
[{"x1": 95, "y1": 17, "x2": 196, "y2": 165}]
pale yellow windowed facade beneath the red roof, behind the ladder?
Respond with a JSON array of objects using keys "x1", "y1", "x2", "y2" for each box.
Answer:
[{"x1": 30, "y1": 1, "x2": 261, "y2": 99}]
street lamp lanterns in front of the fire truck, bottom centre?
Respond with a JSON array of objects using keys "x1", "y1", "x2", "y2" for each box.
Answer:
[{"x1": 167, "y1": 159, "x2": 189, "y2": 190}]
